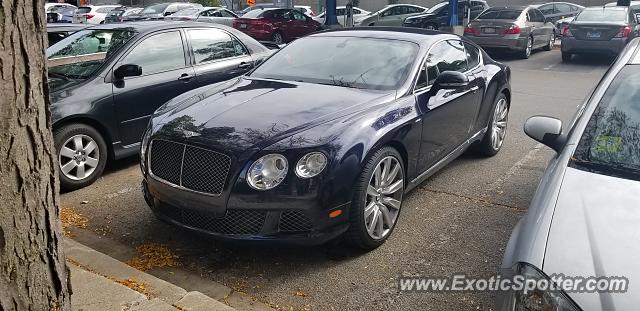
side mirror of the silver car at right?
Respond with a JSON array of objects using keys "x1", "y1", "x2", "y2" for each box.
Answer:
[{"x1": 524, "y1": 116, "x2": 566, "y2": 153}]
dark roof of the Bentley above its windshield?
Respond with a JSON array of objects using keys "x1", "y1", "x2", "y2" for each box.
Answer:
[{"x1": 310, "y1": 26, "x2": 464, "y2": 45}]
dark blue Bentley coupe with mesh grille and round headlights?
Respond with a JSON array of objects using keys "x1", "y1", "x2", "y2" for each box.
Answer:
[{"x1": 141, "y1": 27, "x2": 511, "y2": 249}]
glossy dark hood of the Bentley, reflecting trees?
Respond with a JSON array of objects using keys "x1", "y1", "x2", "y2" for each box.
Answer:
[{"x1": 154, "y1": 78, "x2": 395, "y2": 153}]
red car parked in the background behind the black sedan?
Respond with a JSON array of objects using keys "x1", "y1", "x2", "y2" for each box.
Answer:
[{"x1": 233, "y1": 8, "x2": 322, "y2": 44}]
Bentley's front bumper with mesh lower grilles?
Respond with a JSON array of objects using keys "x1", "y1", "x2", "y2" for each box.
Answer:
[{"x1": 142, "y1": 176, "x2": 350, "y2": 245}]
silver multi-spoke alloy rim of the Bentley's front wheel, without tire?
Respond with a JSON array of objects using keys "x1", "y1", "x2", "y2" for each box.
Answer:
[{"x1": 364, "y1": 156, "x2": 404, "y2": 240}]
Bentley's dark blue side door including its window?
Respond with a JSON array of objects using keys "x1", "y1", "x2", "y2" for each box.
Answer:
[{"x1": 414, "y1": 40, "x2": 480, "y2": 172}]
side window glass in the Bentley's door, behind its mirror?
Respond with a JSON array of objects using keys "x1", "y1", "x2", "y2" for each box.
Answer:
[{"x1": 427, "y1": 40, "x2": 467, "y2": 77}]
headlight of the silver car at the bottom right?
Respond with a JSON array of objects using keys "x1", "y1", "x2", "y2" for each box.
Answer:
[{"x1": 514, "y1": 263, "x2": 581, "y2": 311}]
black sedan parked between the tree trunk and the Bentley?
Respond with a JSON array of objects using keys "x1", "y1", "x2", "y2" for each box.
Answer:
[{"x1": 47, "y1": 22, "x2": 271, "y2": 190}]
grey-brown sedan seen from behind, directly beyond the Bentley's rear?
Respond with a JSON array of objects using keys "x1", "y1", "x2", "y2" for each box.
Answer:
[{"x1": 464, "y1": 6, "x2": 556, "y2": 58}]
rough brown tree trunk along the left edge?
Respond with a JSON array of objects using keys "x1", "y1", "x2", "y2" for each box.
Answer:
[{"x1": 0, "y1": 0, "x2": 70, "y2": 310}]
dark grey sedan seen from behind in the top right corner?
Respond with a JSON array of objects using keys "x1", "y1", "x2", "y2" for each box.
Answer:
[{"x1": 562, "y1": 6, "x2": 640, "y2": 61}]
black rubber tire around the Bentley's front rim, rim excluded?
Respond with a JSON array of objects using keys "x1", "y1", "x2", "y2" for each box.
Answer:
[{"x1": 345, "y1": 147, "x2": 406, "y2": 250}]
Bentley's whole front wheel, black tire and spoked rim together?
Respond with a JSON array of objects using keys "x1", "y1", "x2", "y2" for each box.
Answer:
[{"x1": 345, "y1": 147, "x2": 405, "y2": 250}]
